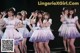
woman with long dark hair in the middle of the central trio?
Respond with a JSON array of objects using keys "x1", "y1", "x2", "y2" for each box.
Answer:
[{"x1": 29, "y1": 12, "x2": 42, "y2": 53}]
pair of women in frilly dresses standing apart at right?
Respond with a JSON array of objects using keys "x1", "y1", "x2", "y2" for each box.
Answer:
[{"x1": 58, "y1": 8, "x2": 80, "y2": 53}]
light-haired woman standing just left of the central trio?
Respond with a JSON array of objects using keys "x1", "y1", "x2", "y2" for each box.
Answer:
[{"x1": 21, "y1": 11, "x2": 32, "y2": 53}]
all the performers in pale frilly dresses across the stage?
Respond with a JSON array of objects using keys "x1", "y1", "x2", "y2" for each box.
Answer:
[{"x1": 0, "y1": 7, "x2": 80, "y2": 53}]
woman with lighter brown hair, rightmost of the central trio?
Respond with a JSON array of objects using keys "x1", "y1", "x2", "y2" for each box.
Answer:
[{"x1": 42, "y1": 13, "x2": 54, "y2": 53}]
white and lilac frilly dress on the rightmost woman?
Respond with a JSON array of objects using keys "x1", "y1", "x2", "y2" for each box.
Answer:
[{"x1": 63, "y1": 16, "x2": 80, "y2": 39}]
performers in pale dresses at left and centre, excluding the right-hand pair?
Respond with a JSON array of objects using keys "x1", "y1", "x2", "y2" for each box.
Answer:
[{"x1": 0, "y1": 7, "x2": 54, "y2": 53}]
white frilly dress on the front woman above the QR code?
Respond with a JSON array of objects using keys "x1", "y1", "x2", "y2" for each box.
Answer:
[{"x1": 2, "y1": 18, "x2": 23, "y2": 45}]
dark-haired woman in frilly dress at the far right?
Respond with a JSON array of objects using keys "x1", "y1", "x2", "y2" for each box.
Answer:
[{"x1": 64, "y1": 8, "x2": 80, "y2": 53}]
